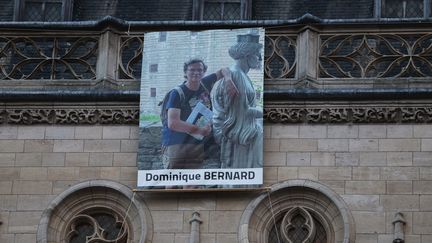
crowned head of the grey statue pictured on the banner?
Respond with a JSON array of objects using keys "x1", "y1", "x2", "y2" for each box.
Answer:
[{"x1": 228, "y1": 30, "x2": 263, "y2": 69}]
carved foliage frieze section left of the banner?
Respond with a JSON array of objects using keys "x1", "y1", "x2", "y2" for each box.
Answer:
[{"x1": 0, "y1": 104, "x2": 139, "y2": 125}]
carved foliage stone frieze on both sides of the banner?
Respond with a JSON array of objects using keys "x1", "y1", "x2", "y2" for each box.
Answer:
[{"x1": 0, "y1": 102, "x2": 432, "y2": 125}]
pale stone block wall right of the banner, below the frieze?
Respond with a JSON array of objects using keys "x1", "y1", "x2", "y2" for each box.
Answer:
[{"x1": 264, "y1": 124, "x2": 432, "y2": 243}]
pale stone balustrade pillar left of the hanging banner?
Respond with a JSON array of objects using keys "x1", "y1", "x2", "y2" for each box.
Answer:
[{"x1": 96, "y1": 30, "x2": 120, "y2": 82}]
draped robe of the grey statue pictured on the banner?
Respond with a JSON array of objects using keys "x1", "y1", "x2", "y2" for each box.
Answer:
[{"x1": 211, "y1": 67, "x2": 263, "y2": 168}]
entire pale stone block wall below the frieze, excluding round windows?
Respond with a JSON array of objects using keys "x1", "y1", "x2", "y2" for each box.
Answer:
[{"x1": 0, "y1": 124, "x2": 432, "y2": 243}]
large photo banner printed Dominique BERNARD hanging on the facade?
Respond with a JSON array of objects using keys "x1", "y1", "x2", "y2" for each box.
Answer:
[{"x1": 137, "y1": 28, "x2": 264, "y2": 189}]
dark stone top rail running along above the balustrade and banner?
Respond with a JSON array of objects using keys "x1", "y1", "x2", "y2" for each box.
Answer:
[{"x1": 0, "y1": 13, "x2": 431, "y2": 31}]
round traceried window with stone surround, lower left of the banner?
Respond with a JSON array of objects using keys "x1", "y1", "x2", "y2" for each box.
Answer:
[{"x1": 36, "y1": 180, "x2": 152, "y2": 243}]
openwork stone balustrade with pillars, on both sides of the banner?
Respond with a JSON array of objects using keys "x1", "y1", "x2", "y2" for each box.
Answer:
[{"x1": 0, "y1": 24, "x2": 432, "y2": 90}]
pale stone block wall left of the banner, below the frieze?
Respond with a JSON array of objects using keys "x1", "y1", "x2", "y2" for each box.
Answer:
[{"x1": 0, "y1": 126, "x2": 138, "y2": 243}]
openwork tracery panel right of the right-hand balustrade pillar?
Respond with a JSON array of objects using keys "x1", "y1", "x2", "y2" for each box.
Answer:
[{"x1": 319, "y1": 32, "x2": 432, "y2": 78}]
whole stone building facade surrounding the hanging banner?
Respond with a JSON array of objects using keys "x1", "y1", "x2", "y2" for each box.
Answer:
[{"x1": 0, "y1": 0, "x2": 432, "y2": 243}]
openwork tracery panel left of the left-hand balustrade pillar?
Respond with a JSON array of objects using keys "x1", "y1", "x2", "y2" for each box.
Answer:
[{"x1": 0, "y1": 35, "x2": 99, "y2": 80}]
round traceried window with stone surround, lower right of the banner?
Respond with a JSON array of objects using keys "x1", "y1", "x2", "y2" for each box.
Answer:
[{"x1": 238, "y1": 180, "x2": 355, "y2": 243}]
